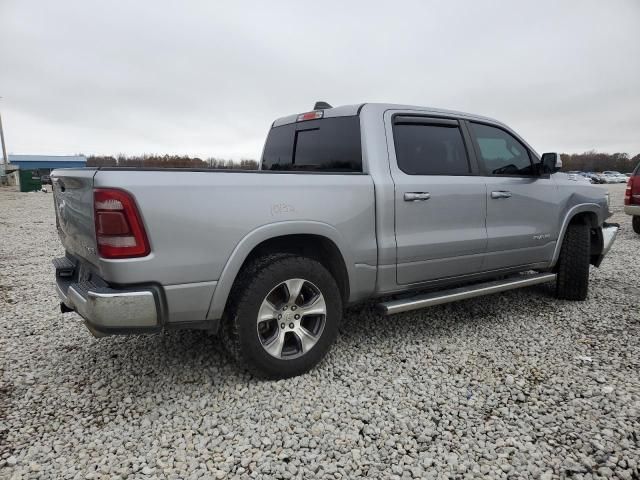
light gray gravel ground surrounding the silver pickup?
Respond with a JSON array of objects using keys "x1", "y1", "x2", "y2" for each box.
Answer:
[{"x1": 0, "y1": 185, "x2": 640, "y2": 479}]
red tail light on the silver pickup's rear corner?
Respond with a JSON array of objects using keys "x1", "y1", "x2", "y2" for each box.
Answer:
[{"x1": 93, "y1": 188, "x2": 150, "y2": 258}]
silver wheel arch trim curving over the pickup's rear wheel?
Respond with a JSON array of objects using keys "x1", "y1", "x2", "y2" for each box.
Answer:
[{"x1": 207, "y1": 221, "x2": 354, "y2": 320}]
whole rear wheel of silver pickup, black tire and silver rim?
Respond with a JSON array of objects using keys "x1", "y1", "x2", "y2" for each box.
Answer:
[{"x1": 223, "y1": 254, "x2": 342, "y2": 378}]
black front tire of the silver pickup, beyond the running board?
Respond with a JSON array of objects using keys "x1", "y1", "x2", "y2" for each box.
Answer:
[{"x1": 556, "y1": 223, "x2": 591, "y2": 300}]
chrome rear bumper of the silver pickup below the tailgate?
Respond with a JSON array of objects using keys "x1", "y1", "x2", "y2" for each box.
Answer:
[{"x1": 54, "y1": 257, "x2": 162, "y2": 336}]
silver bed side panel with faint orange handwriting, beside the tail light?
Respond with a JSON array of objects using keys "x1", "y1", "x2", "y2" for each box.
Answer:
[{"x1": 95, "y1": 170, "x2": 376, "y2": 292}]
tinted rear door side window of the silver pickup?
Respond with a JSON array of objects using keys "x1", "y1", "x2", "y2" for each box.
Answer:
[{"x1": 393, "y1": 117, "x2": 471, "y2": 175}]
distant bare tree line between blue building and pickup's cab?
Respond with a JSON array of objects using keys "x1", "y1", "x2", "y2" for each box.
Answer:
[{"x1": 87, "y1": 155, "x2": 258, "y2": 170}]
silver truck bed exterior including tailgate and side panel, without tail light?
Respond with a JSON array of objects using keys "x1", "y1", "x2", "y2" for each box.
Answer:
[{"x1": 52, "y1": 167, "x2": 377, "y2": 321}]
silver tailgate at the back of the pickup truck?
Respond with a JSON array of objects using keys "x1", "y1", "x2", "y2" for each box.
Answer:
[{"x1": 51, "y1": 169, "x2": 98, "y2": 265}]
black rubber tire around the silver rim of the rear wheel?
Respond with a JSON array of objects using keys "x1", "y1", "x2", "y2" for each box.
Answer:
[{"x1": 222, "y1": 253, "x2": 342, "y2": 379}]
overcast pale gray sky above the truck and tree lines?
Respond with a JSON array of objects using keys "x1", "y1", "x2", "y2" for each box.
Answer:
[{"x1": 0, "y1": 0, "x2": 640, "y2": 159}]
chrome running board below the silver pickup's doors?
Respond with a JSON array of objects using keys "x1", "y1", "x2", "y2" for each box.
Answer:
[{"x1": 378, "y1": 273, "x2": 556, "y2": 315}]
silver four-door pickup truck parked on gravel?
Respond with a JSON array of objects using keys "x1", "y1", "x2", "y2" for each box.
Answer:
[{"x1": 51, "y1": 102, "x2": 618, "y2": 377}]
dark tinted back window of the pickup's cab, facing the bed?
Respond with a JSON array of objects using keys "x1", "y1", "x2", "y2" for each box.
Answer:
[{"x1": 262, "y1": 116, "x2": 362, "y2": 173}]
